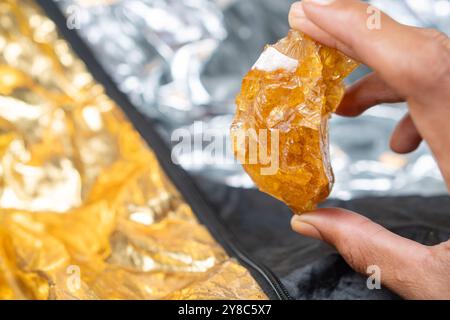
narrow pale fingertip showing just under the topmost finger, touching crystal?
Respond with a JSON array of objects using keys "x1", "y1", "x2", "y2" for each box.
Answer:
[{"x1": 289, "y1": 2, "x2": 358, "y2": 60}]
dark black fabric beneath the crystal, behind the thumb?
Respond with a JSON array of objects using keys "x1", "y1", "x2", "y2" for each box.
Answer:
[{"x1": 197, "y1": 178, "x2": 450, "y2": 299}]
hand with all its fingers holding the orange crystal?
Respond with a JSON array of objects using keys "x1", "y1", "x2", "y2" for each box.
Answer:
[{"x1": 289, "y1": 0, "x2": 450, "y2": 299}]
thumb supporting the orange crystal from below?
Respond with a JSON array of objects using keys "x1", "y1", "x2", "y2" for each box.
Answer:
[{"x1": 291, "y1": 209, "x2": 430, "y2": 298}]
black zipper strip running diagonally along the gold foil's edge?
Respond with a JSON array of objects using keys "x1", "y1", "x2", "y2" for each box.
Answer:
[{"x1": 36, "y1": 0, "x2": 293, "y2": 300}]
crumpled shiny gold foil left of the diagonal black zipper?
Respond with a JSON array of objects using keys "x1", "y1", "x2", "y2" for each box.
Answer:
[{"x1": 0, "y1": 0, "x2": 266, "y2": 299}]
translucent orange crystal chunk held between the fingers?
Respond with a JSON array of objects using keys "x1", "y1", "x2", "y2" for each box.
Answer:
[{"x1": 231, "y1": 30, "x2": 357, "y2": 213}]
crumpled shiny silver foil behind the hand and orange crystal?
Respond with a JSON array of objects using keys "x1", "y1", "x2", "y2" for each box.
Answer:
[{"x1": 55, "y1": 0, "x2": 450, "y2": 199}]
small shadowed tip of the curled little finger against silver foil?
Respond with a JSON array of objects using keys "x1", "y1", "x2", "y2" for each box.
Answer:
[{"x1": 390, "y1": 114, "x2": 422, "y2": 153}]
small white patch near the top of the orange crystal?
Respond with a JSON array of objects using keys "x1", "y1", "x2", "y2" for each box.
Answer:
[{"x1": 252, "y1": 47, "x2": 298, "y2": 72}]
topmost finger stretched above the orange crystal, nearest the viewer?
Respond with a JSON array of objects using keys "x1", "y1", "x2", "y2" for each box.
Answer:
[{"x1": 294, "y1": 0, "x2": 423, "y2": 95}]
